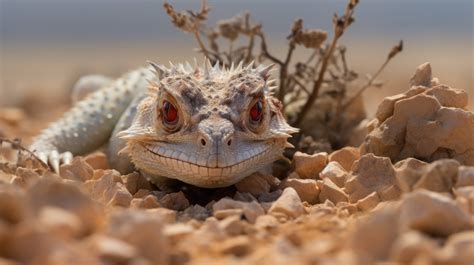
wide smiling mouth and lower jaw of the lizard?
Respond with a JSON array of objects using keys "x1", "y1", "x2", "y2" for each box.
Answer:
[{"x1": 132, "y1": 141, "x2": 275, "y2": 188}]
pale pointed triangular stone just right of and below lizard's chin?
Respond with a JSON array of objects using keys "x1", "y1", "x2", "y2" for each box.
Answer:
[{"x1": 268, "y1": 187, "x2": 306, "y2": 218}]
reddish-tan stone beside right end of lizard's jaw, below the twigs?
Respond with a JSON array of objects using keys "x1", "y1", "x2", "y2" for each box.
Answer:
[{"x1": 293, "y1": 151, "x2": 328, "y2": 179}]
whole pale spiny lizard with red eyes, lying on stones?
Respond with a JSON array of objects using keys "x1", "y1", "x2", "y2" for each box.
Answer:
[{"x1": 31, "y1": 60, "x2": 297, "y2": 188}]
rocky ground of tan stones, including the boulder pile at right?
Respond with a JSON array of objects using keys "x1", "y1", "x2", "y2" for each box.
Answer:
[{"x1": 0, "y1": 65, "x2": 474, "y2": 265}]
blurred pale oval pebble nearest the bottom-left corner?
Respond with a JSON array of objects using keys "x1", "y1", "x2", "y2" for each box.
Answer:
[{"x1": 38, "y1": 206, "x2": 83, "y2": 239}]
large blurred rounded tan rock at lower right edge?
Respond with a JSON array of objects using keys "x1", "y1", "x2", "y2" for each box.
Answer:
[{"x1": 400, "y1": 190, "x2": 474, "y2": 236}]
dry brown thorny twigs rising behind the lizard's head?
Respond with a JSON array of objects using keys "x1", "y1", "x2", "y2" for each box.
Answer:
[{"x1": 164, "y1": 0, "x2": 402, "y2": 148}]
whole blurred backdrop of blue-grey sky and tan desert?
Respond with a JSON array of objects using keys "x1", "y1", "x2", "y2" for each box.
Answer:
[{"x1": 0, "y1": 0, "x2": 474, "y2": 112}]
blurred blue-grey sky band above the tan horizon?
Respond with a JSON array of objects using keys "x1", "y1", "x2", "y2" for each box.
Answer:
[{"x1": 0, "y1": 0, "x2": 473, "y2": 42}]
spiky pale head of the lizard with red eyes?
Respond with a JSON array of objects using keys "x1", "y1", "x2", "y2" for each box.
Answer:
[{"x1": 119, "y1": 61, "x2": 297, "y2": 188}]
